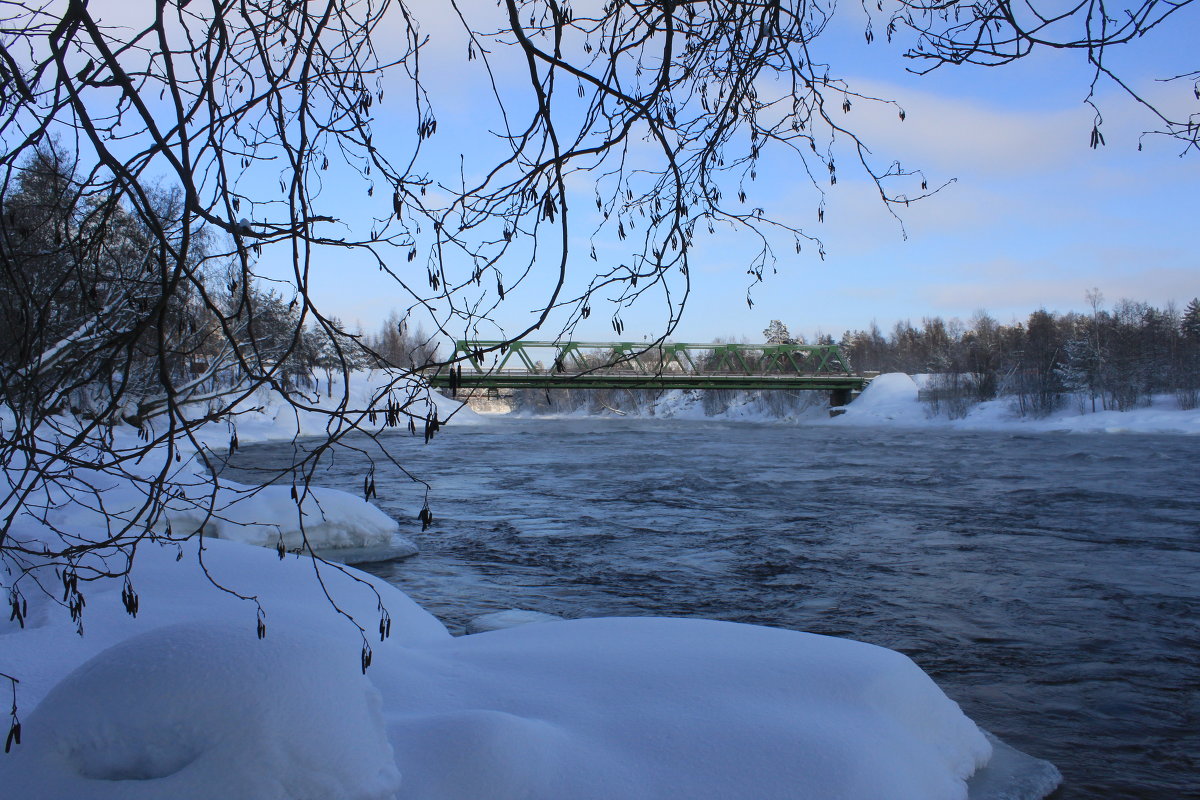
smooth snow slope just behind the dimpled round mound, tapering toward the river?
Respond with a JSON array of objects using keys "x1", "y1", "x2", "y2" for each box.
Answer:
[{"x1": 0, "y1": 537, "x2": 450, "y2": 710}]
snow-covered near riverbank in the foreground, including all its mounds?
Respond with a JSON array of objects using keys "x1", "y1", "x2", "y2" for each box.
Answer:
[{"x1": 0, "y1": 371, "x2": 1058, "y2": 800}]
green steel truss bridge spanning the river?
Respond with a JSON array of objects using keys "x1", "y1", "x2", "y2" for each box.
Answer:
[{"x1": 426, "y1": 341, "x2": 869, "y2": 405}]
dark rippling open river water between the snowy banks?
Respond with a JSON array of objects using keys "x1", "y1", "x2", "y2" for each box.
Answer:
[{"x1": 225, "y1": 419, "x2": 1200, "y2": 800}]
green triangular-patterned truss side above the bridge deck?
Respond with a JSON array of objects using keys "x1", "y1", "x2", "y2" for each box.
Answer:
[{"x1": 452, "y1": 339, "x2": 853, "y2": 375}]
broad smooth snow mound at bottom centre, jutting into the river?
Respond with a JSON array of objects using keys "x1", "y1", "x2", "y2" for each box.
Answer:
[{"x1": 373, "y1": 618, "x2": 991, "y2": 800}]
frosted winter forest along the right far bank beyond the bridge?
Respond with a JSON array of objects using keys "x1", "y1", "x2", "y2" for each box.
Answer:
[{"x1": 840, "y1": 302, "x2": 1200, "y2": 417}]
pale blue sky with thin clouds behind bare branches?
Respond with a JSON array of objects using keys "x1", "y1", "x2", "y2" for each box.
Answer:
[{"x1": 84, "y1": 0, "x2": 1200, "y2": 342}]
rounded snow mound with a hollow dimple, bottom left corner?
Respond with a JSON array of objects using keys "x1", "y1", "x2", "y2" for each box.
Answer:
[{"x1": 5, "y1": 622, "x2": 400, "y2": 800}]
